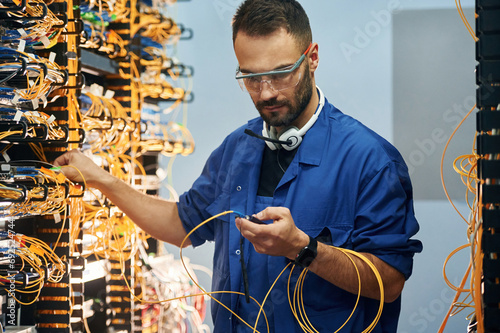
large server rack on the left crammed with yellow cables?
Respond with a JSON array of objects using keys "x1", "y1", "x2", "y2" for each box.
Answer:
[{"x1": 0, "y1": 0, "x2": 199, "y2": 333}]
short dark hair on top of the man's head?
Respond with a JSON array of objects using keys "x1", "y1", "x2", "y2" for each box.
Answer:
[{"x1": 233, "y1": 0, "x2": 312, "y2": 50}]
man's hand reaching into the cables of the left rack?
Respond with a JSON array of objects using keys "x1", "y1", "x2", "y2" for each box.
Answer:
[{"x1": 54, "y1": 149, "x2": 110, "y2": 187}]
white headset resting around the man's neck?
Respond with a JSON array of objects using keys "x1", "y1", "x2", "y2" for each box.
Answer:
[{"x1": 262, "y1": 87, "x2": 325, "y2": 150}]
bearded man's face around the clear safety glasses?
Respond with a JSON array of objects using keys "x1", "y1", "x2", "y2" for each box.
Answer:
[{"x1": 234, "y1": 30, "x2": 313, "y2": 128}]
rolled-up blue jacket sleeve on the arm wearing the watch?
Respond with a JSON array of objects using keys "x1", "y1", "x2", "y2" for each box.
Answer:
[{"x1": 352, "y1": 161, "x2": 422, "y2": 279}]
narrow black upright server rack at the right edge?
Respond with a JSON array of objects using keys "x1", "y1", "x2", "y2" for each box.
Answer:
[{"x1": 476, "y1": 0, "x2": 500, "y2": 333}]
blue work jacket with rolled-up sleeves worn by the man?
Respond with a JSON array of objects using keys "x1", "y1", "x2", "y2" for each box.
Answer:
[{"x1": 178, "y1": 94, "x2": 422, "y2": 333}]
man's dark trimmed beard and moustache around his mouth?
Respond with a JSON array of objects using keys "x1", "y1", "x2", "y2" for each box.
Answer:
[{"x1": 255, "y1": 66, "x2": 313, "y2": 127}]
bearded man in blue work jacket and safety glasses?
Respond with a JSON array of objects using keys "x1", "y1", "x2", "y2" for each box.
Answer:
[{"x1": 55, "y1": 0, "x2": 422, "y2": 332}]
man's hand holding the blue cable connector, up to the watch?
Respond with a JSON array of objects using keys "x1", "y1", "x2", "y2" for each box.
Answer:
[{"x1": 236, "y1": 207, "x2": 309, "y2": 260}]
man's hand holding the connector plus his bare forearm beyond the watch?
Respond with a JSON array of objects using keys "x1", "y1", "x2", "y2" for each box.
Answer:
[{"x1": 236, "y1": 207, "x2": 405, "y2": 302}]
